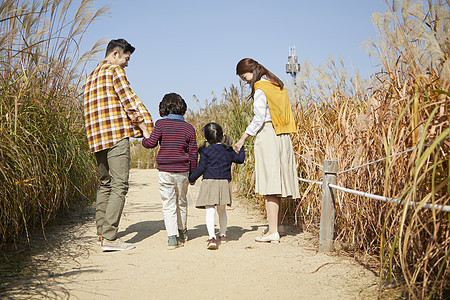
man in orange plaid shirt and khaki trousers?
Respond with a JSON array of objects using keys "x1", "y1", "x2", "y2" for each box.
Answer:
[{"x1": 83, "y1": 39, "x2": 153, "y2": 251}]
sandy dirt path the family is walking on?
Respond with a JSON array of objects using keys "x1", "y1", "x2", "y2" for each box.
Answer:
[{"x1": 3, "y1": 169, "x2": 376, "y2": 300}]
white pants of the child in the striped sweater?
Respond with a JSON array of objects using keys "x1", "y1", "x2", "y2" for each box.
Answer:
[{"x1": 158, "y1": 171, "x2": 189, "y2": 236}]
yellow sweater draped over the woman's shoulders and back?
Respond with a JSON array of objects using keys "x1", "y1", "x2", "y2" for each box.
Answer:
[{"x1": 255, "y1": 80, "x2": 297, "y2": 134}]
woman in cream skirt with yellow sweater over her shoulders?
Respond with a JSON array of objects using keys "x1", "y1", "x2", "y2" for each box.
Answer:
[{"x1": 235, "y1": 58, "x2": 300, "y2": 243}]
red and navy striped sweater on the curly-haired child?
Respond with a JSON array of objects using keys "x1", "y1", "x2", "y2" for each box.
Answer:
[{"x1": 142, "y1": 118, "x2": 198, "y2": 173}]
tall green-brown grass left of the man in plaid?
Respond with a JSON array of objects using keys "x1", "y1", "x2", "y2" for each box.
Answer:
[{"x1": 0, "y1": 0, "x2": 105, "y2": 246}]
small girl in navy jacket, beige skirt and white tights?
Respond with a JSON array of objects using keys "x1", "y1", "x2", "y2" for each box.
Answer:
[{"x1": 189, "y1": 123, "x2": 245, "y2": 249}]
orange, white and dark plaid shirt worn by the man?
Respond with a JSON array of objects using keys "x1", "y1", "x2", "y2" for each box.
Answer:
[{"x1": 83, "y1": 60, "x2": 153, "y2": 152}]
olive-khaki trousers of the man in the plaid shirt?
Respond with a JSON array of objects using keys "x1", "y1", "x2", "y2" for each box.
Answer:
[{"x1": 95, "y1": 138, "x2": 130, "y2": 240}]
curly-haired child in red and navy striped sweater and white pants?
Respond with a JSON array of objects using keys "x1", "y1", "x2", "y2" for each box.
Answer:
[{"x1": 142, "y1": 93, "x2": 198, "y2": 250}]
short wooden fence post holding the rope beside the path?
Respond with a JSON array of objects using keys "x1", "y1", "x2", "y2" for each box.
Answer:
[{"x1": 319, "y1": 160, "x2": 337, "y2": 252}]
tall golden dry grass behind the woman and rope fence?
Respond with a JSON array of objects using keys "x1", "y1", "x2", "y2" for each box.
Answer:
[{"x1": 185, "y1": 0, "x2": 450, "y2": 298}]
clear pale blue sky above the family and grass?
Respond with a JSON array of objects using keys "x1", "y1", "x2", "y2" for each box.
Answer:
[{"x1": 81, "y1": 0, "x2": 386, "y2": 120}]
